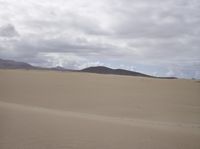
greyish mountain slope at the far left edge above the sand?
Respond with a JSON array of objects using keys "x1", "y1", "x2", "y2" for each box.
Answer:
[{"x1": 0, "y1": 59, "x2": 35, "y2": 69}]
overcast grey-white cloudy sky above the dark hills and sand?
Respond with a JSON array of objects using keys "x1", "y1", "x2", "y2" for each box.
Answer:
[{"x1": 0, "y1": 0, "x2": 200, "y2": 79}]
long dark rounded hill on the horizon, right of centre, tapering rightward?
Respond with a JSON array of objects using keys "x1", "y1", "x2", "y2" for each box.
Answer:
[{"x1": 81, "y1": 66, "x2": 176, "y2": 79}]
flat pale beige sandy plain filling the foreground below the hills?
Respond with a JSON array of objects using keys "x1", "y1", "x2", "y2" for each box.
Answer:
[{"x1": 0, "y1": 70, "x2": 200, "y2": 149}]
